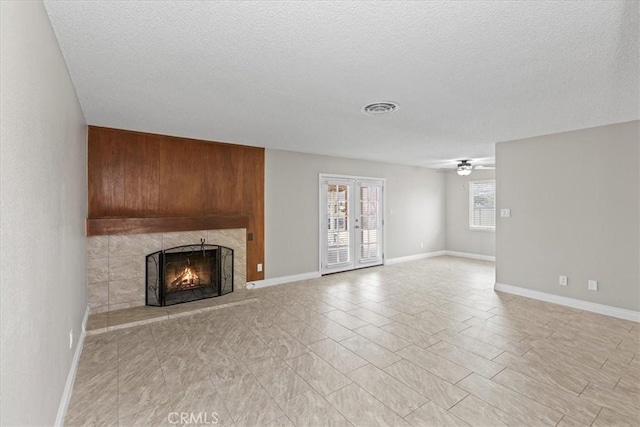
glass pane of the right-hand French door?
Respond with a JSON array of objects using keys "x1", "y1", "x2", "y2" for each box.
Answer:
[{"x1": 360, "y1": 186, "x2": 381, "y2": 261}]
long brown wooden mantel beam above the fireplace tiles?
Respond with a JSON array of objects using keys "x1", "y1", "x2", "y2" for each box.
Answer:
[{"x1": 87, "y1": 215, "x2": 249, "y2": 236}]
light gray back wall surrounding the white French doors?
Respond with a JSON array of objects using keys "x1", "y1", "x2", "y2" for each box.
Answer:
[{"x1": 265, "y1": 150, "x2": 445, "y2": 279}]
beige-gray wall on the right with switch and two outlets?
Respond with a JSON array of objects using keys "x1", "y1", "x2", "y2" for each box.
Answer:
[{"x1": 496, "y1": 121, "x2": 640, "y2": 310}]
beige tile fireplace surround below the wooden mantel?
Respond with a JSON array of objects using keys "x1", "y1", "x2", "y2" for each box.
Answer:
[{"x1": 87, "y1": 228, "x2": 247, "y2": 313}]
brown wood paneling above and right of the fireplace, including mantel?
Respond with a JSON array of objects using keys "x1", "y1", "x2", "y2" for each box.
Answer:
[{"x1": 87, "y1": 126, "x2": 264, "y2": 281}]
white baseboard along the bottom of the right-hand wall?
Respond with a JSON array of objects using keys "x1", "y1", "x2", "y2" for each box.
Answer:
[{"x1": 493, "y1": 282, "x2": 640, "y2": 322}]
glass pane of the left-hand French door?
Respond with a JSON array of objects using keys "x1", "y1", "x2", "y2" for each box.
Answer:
[{"x1": 327, "y1": 184, "x2": 351, "y2": 265}]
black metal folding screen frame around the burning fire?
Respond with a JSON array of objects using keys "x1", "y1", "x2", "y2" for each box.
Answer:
[{"x1": 145, "y1": 241, "x2": 235, "y2": 307}]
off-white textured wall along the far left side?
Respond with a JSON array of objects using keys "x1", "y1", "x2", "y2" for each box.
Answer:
[{"x1": 0, "y1": 1, "x2": 87, "y2": 426}]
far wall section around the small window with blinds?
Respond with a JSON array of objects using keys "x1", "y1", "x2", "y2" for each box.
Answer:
[{"x1": 444, "y1": 169, "x2": 496, "y2": 257}]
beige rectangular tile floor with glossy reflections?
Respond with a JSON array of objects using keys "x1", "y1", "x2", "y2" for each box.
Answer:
[{"x1": 66, "y1": 257, "x2": 640, "y2": 426}]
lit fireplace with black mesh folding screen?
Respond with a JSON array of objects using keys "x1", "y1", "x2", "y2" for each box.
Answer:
[{"x1": 146, "y1": 239, "x2": 233, "y2": 307}]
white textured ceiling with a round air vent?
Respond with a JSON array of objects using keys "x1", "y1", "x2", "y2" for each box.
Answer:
[{"x1": 45, "y1": 0, "x2": 640, "y2": 166}]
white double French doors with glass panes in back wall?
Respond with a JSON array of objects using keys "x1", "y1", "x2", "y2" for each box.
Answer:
[{"x1": 320, "y1": 175, "x2": 384, "y2": 274}]
